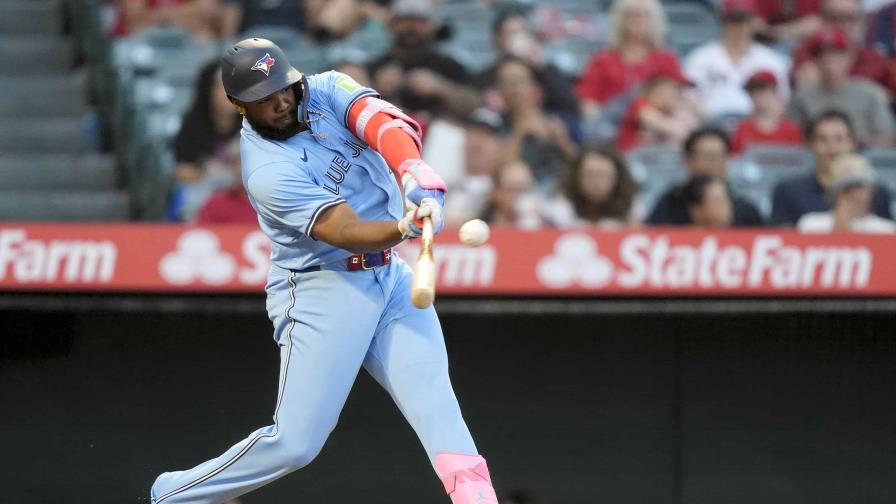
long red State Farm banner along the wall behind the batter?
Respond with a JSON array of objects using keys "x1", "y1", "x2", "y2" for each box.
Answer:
[{"x1": 0, "y1": 224, "x2": 896, "y2": 296}]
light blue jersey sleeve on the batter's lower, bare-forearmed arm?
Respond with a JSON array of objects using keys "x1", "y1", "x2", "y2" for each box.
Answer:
[{"x1": 246, "y1": 163, "x2": 345, "y2": 238}]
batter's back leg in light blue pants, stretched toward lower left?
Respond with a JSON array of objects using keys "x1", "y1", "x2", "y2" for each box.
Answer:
[{"x1": 152, "y1": 271, "x2": 383, "y2": 504}]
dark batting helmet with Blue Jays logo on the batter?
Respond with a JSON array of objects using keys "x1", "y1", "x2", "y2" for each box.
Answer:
[{"x1": 221, "y1": 38, "x2": 302, "y2": 102}]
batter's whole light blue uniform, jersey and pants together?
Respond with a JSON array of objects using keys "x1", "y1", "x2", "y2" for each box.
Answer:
[{"x1": 151, "y1": 69, "x2": 486, "y2": 504}]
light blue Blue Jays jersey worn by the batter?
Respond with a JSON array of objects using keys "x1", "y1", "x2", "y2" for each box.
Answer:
[{"x1": 240, "y1": 71, "x2": 404, "y2": 270}]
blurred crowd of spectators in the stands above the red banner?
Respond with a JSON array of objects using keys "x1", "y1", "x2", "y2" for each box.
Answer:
[{"x1": 111, "y1": 0, "x2": 896, "y2": 232}]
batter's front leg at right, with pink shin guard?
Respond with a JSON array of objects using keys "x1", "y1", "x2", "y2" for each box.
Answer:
[{"x1": 364, "y1": 261, "x2": 498, "y2": 504}]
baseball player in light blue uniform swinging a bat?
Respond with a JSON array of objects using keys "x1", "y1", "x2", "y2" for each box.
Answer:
[{"x1": 151, "y1": 38, "x2": 497, "y2": 504}]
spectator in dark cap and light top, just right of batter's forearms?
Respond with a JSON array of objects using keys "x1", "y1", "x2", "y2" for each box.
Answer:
[{"x1": 445, "y1": 108, "x2": 504, "y2": 226}]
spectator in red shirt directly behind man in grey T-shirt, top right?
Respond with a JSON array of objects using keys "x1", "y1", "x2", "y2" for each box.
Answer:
[{"x1": 793, "y1": 0, "x2": 896, "y2": 93}]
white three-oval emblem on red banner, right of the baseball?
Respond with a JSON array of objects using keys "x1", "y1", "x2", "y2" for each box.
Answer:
[{"x1": 536, "y1": 234, "x2": 613, "y2": 289}]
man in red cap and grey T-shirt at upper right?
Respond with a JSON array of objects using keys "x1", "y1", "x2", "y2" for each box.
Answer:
[{"x1": 788, "y1": 29, "x2": 893, "y2": 147}]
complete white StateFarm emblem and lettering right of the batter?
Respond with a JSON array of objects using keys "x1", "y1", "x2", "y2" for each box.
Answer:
[{"x1": 536, "y1": 233, "x2": 873, "y2": 290}]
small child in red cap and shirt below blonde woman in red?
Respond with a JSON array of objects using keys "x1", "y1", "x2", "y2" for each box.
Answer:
[{"x1": 616, "y1": 69, "x2": 701, "y2": 152}]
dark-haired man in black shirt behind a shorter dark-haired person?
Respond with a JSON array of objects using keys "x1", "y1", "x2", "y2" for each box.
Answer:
[{"x1": 647, "y1": 127, "x2": 763, "y2": 227}]
